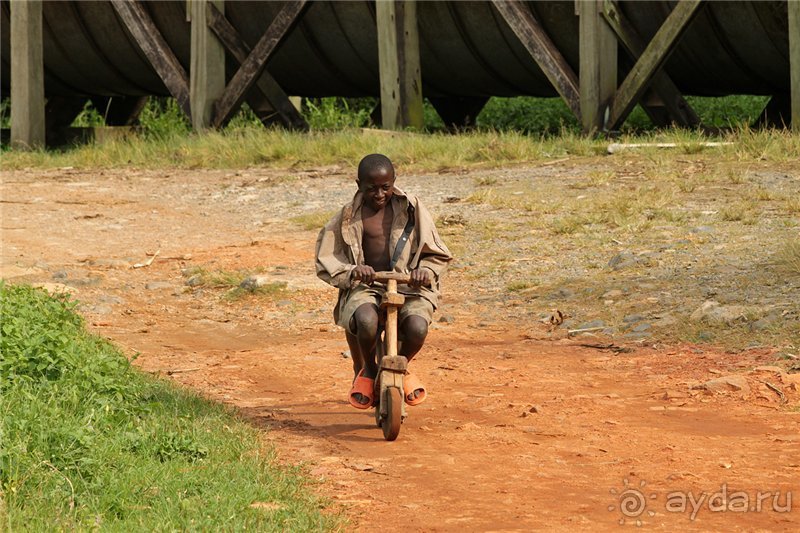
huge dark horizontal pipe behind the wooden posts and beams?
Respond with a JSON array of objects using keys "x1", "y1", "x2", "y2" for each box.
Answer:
[{"x1": 0, "y1": 0, "x2": 790, "y2": 97}]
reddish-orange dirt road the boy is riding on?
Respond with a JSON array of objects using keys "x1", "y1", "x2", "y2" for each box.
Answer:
[{"x1": 2, "y1": 165, "x2": 800, "y2": 531}]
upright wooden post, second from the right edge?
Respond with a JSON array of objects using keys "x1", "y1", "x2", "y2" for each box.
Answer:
[{"x1": 576, "y1": 0, "x2": 617, "y2": 133}]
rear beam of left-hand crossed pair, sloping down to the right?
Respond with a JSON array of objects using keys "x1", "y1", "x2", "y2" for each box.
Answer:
[{"x1": 206, "y1": 3, "x2": 308, "y2": 131}]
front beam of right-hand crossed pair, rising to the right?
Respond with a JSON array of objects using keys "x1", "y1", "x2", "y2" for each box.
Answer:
[{"x1": 607, "y1": 0, "x2": 703, "y2": 129}]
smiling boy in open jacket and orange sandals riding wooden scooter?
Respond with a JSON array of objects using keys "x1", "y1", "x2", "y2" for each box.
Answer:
[{"x1": 316, "y1": 154, "x2": 452, "y2": 409}]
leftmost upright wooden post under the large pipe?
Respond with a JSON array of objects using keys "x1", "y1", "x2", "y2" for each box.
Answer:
[{"x1": 10, "y1": 0, "x2": 45, "y2": 150}]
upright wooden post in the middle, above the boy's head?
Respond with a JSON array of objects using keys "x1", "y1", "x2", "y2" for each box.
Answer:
[{"x1": 375, "y1": 0, "x2": 425, "y2": 130}]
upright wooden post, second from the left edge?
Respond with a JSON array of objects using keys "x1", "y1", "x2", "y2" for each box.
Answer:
[{"x1": 189, "y1": 0, "x2": 225, "y2": 131}]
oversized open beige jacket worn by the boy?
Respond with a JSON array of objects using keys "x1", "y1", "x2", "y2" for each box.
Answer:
[{"x1": 316, "y1": 187, "x2": 453, "y2": 321}]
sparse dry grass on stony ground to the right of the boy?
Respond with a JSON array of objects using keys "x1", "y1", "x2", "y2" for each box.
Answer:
[{"x1": 438, "y1": 139, "x2": 800, "y2": 349}]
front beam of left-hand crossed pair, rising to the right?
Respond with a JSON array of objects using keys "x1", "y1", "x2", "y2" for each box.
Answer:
[{"x1": 212, "y1": 0, "x2": 308, "y2": 128}]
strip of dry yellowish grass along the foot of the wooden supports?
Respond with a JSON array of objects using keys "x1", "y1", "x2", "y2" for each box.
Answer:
[{"x1": 3, "y1": 128, "x2": 800, "y2": 171}]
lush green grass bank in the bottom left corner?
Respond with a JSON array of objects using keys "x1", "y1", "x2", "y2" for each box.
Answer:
[{"x1": 0, "y1": 282, "x2": 339, "y2": 531}]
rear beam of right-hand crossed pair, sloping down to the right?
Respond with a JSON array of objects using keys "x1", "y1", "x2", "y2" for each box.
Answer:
[{"x1": 603, "y1": 2, "x2": 700, "y2": 127}]
